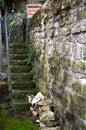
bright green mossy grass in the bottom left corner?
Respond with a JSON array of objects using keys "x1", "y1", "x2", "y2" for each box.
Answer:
[{"x1": 0, "y1": 111, "x2": 38, "y2": 130}]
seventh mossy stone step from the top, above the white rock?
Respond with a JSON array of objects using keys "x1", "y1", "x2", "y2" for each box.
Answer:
[{"x1": 11, "y1": 81, "x2": 35, "y2": 90}]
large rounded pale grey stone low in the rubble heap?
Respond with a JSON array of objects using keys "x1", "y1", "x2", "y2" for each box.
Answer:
[{"x1": 40, "y1": 111, "x2": 55, "y2": 122}]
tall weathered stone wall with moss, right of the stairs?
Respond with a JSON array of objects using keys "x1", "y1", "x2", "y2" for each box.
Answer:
[{"x1": 29, "y1": 0, "x2": 86, "y2": 130}]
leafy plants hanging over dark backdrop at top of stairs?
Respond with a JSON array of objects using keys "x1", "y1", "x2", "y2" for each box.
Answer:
[{"x1": 7, "y1": 10, "x2": 27, "y2": 42}]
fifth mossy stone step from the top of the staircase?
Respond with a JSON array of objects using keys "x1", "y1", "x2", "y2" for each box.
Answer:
[{"x1": 10, "y1": 66, "x2": 31, "y2": 73}]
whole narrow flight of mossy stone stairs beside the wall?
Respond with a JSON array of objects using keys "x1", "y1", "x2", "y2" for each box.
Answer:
[{"x1": 9, "y1": 43, "x2": 37, "y2": 111}]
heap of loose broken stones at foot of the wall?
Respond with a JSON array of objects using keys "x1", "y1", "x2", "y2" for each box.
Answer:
[{"x1": 28, "y1": 92, "x2": 60, "y2": 130}]
